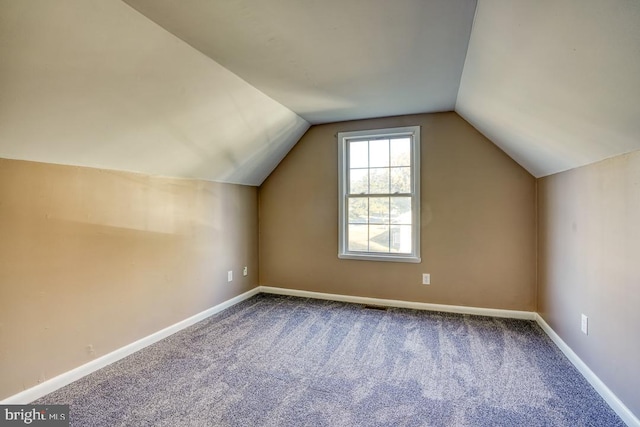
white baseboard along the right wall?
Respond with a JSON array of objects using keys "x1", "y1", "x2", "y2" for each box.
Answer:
[{"x1": 535, "y1": 313, "x2": 640, "y2": 427}]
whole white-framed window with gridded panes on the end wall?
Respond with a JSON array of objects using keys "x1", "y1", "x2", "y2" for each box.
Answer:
[{"x1": 338, "y1": 126, "x2": 420, "y2": 262}]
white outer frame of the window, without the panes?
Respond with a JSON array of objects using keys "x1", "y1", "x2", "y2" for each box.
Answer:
[{"x1": 338, "y1": 126, "x2": 421, "y2": 263}]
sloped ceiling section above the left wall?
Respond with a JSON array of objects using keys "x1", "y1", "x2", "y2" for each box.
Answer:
[{"x1": 0, "y1": 0, "x2": 309, "y2": 185}]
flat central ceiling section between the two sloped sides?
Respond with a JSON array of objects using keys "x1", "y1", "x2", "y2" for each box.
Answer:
[{"x1": 125, "y1": 0, "x2": 476, "y2": 124}]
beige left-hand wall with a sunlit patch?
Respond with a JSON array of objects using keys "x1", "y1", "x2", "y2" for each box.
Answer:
[{"x1": 0, "y1": 159, "x2": 258, "y2": 399}]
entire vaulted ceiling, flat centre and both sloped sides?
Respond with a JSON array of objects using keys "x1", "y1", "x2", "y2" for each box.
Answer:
[{"x1": 0, "y1": 0, "x2": 640, "y2": 185}]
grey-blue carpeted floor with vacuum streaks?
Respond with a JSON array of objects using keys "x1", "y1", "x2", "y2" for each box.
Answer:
[{"x1": 34, "y1": 294, "x2": 624, "y2": 427}]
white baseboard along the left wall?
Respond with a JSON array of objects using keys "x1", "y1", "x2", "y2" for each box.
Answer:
[{"x1": 0, "y1": 287, "x2": 260, "y2": 405}]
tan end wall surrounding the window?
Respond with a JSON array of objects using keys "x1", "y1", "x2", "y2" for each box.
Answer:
[{"x1": 259, "y1": 113, "x2": 536, "y2": 310}]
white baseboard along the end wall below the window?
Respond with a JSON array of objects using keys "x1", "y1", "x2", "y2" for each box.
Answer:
[{"x1": 259, "y1": 286, "x2": 536, "y2": 320}]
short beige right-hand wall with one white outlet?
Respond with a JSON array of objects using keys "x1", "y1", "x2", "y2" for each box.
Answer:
[{"x1": 538, "y1": 152, "x2": 640, "y2": 414}]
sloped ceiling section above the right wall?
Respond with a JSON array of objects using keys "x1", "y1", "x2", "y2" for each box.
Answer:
[{"x1": 456, "y1": 0, "x2": 640, "y2": 177}]
